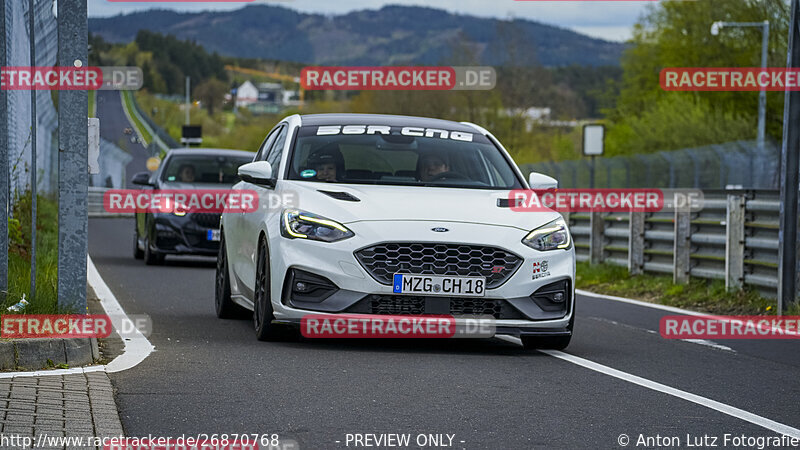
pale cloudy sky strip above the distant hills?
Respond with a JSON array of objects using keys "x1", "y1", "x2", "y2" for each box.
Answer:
[{"x1": 88, "y1": 0, "x2": 653, "y2": 41}]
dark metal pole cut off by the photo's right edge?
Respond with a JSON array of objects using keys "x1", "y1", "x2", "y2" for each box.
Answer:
[{"x1": 778, "y1": 0, "x2": 800, "y2": 315}]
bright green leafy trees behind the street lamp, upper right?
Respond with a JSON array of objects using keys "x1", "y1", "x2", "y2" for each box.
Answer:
[{"x1": 607, "y1": 0, "x2": 789, "y2": 154}]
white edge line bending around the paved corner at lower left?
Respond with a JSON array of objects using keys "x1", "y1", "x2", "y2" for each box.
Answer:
[{"x1": 0, "y1": 255, "x2": 155, "y2": 379}]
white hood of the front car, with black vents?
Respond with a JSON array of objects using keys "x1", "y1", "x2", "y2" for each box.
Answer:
[{"x1": 281, "y1": 180, "x2": 560, "y2": 231}]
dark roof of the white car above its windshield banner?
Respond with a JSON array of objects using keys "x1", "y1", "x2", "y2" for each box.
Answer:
[{"x1": 300, "y1": 113, "x2": 476, "y2": 133}]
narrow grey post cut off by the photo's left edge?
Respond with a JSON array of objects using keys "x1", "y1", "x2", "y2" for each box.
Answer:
[{"x1": 0, "y1": 0, "x2": 11, "y2": 302}]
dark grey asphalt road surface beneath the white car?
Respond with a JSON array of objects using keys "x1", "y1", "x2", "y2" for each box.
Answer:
[{"x1": 89, "y1": 219, "x2": 800, "y2": 449}]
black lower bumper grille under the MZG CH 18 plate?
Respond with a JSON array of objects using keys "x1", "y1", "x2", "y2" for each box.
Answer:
[{"x1": 345, "y1": 294, "x2": 525, "y2": 319}]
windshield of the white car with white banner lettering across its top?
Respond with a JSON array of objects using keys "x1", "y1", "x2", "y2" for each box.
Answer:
[{"x1": 288, "y1": 125, "x2": 521, "y2": 189}]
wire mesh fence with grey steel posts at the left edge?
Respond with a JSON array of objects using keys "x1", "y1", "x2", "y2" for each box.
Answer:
[{"x1": 0, "y1": 0, "x2": 89, "y2": 311}]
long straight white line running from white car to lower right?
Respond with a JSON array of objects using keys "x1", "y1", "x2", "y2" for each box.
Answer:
[{"x1": 495, "y1": 335, "x2": 800, "y2": 439}]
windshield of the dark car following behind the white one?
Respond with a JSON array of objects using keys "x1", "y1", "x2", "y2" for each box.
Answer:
[{"x1": 161, "y1": 155, "x2": 253, "y2": 184}]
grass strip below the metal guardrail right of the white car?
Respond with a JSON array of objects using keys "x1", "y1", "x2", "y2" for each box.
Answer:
[{"x1": 575, "y1": 262, "x2": 800, "y2": 315}]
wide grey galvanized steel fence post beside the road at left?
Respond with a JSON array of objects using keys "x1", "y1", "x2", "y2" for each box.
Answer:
[{"x1": 58, "y1": 0, "x2": 89, "y2": 313}]
